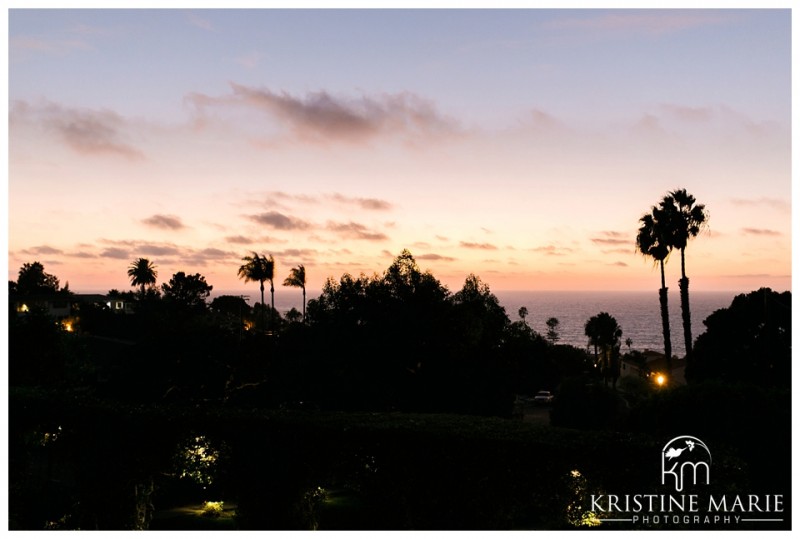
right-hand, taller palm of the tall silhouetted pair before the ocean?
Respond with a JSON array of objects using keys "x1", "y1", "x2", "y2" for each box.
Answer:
[{"x1": 660, "y1": 189, "x2": 708, "y2": 356}]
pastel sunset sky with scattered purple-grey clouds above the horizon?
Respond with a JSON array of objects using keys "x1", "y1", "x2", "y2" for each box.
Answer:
[{"x1": 7, "y1": 5, "x2": 792, "y2": 297}]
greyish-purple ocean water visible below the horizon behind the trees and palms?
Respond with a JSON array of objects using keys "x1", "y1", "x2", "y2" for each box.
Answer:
[{"x1": 214, "y1": 287, "x2": 739, "y2": 356}]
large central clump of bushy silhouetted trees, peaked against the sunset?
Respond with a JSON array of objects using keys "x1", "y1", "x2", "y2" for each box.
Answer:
[{"x1": 281, "y1": 251, "x2": 588, "y2": 415}]
